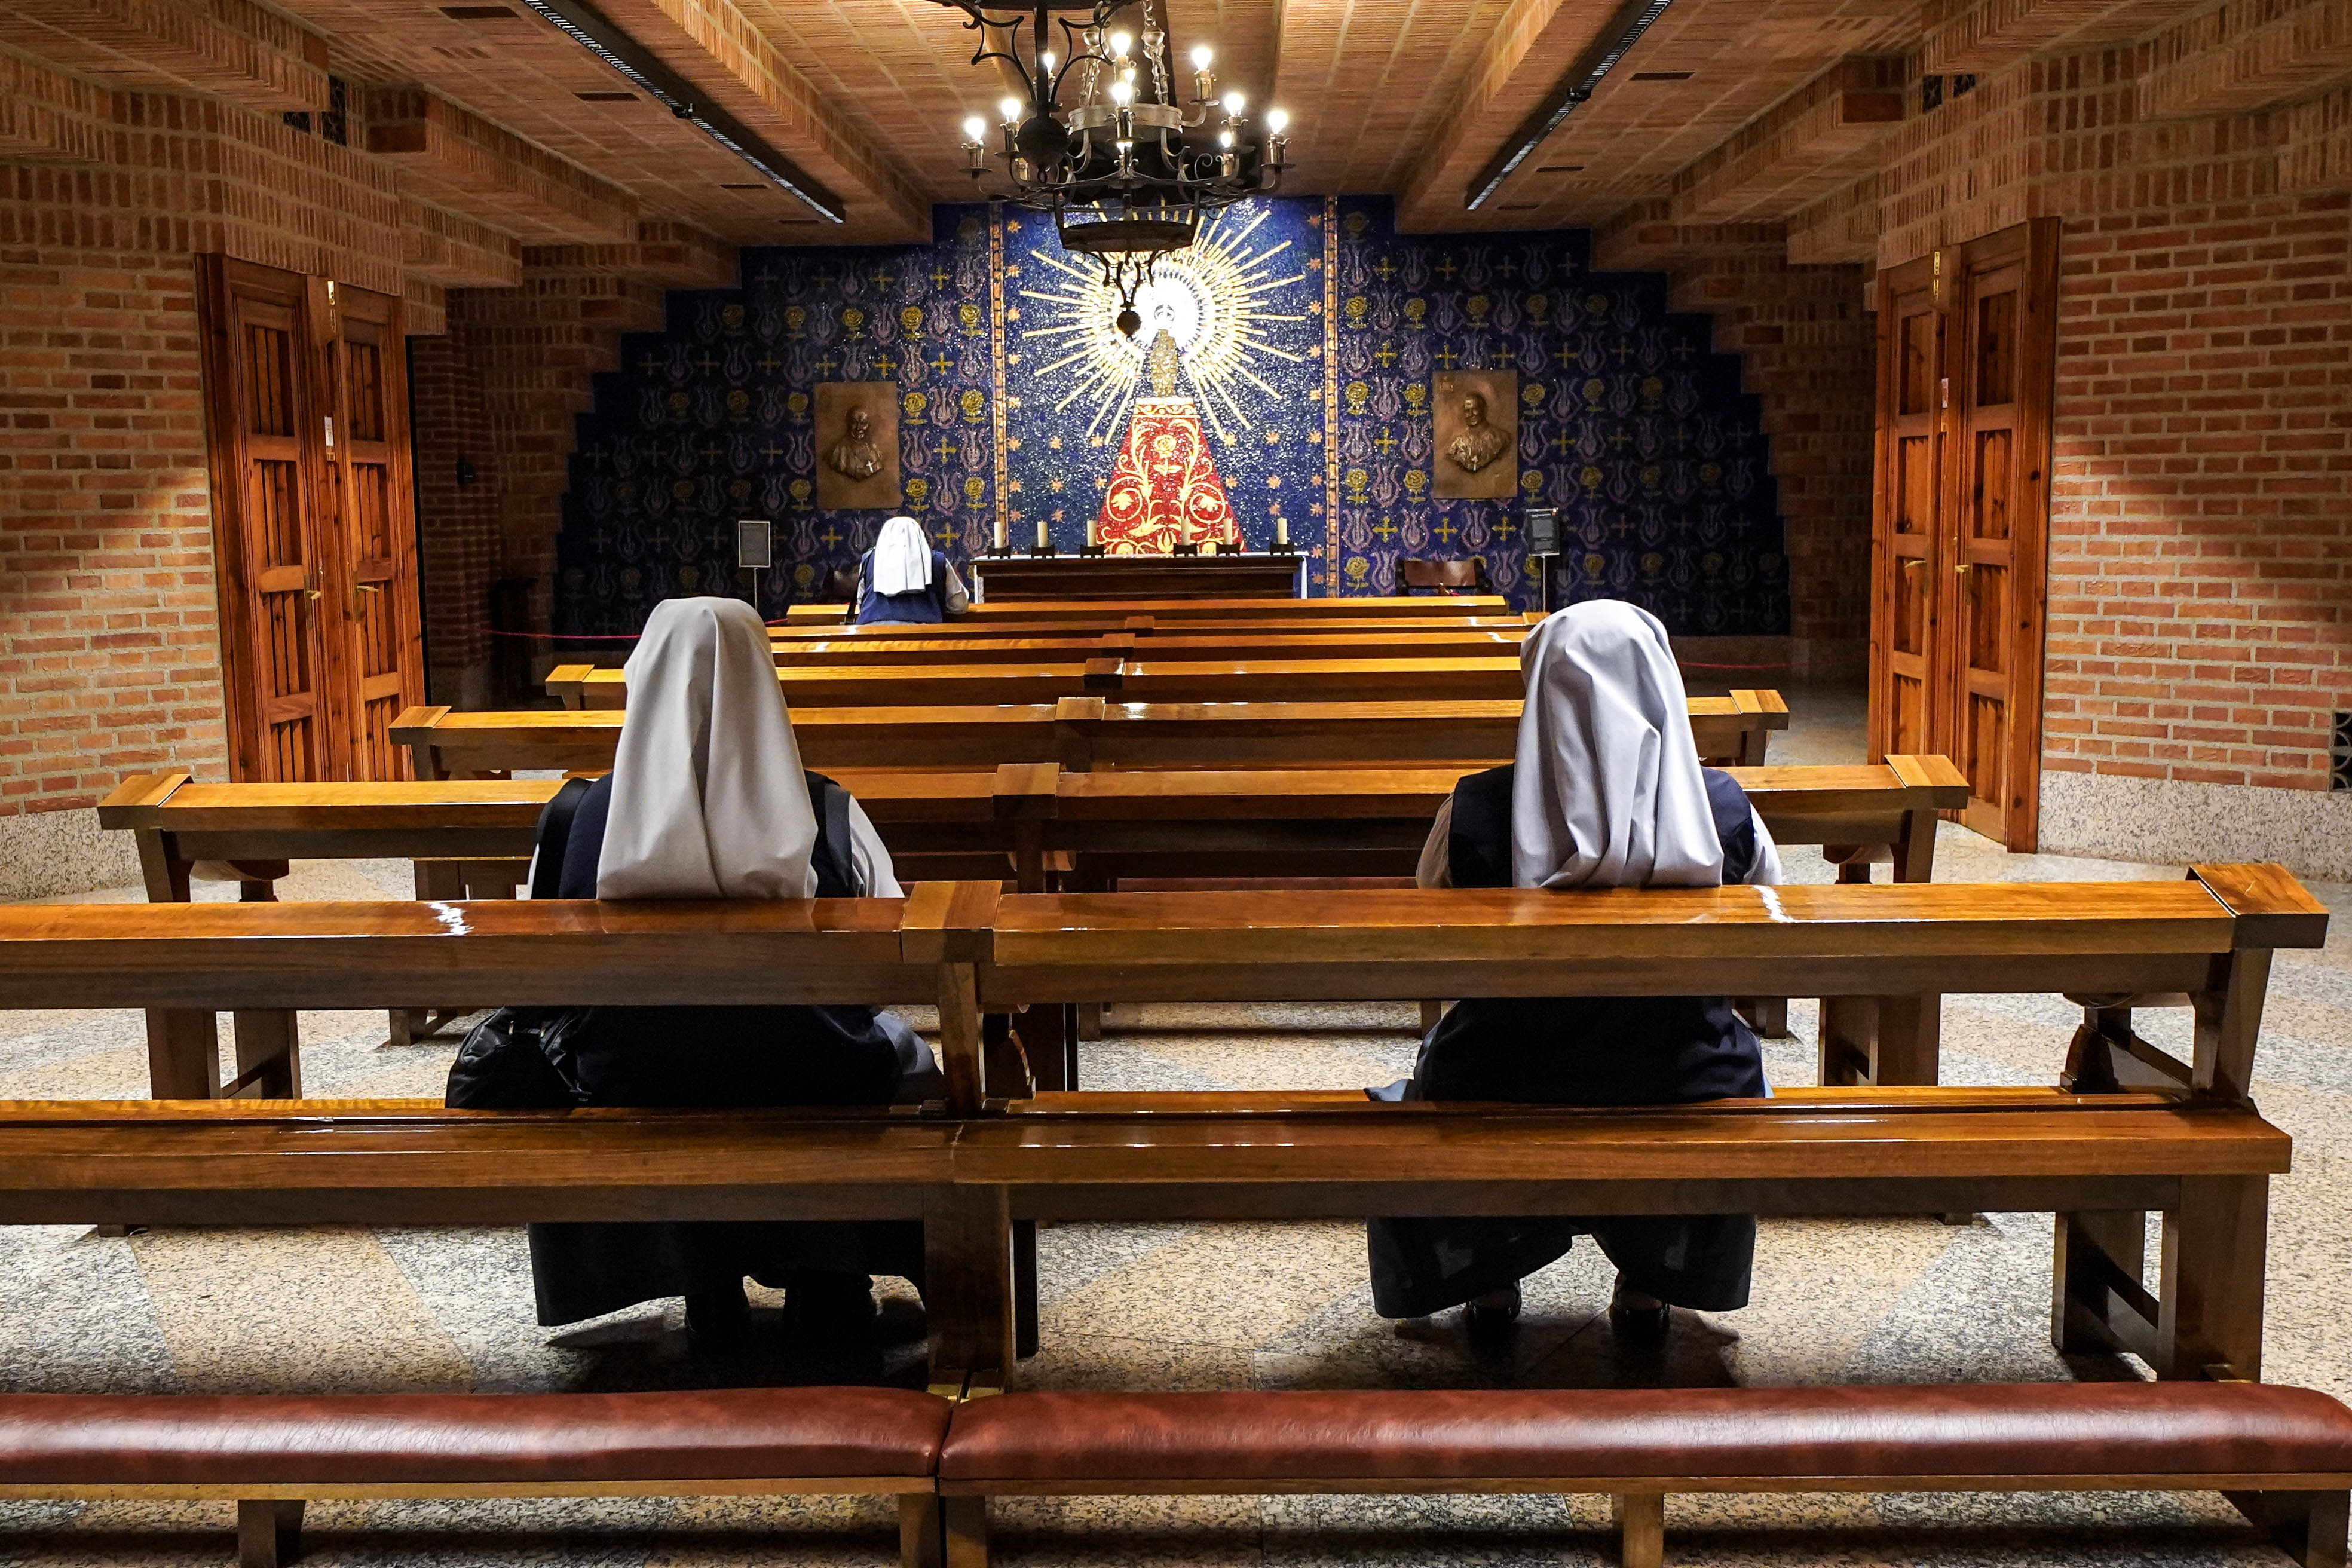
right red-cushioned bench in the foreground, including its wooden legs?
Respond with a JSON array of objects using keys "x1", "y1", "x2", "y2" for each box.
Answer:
[{"x1": 938, "y1": 1382, "x2": 2352, "y2": 1568}]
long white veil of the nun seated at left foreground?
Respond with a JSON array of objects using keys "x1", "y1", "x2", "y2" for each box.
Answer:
[{"x1": 595, "y1": 599, "x2": 816, "y2": 898}]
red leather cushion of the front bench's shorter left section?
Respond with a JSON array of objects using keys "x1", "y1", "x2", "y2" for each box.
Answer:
[{"x1": 0, "y1": 1389, "x2": 948, "y2": 1486}]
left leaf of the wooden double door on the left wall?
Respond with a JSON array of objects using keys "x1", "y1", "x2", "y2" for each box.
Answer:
[{"x1": 198, "y1": 256, "x2": 344, "y2": 783}]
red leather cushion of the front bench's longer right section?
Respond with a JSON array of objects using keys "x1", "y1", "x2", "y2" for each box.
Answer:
[{"x1": 938, "y1": 1382, "x2": 2352, "y2": 1490}]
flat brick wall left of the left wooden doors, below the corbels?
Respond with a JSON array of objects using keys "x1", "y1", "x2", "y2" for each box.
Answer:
[{"x1": 0, "y1": 247, "x2": 228, "y2": 816}]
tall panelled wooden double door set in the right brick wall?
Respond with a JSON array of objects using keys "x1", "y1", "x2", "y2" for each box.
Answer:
[{"x1": 1870, "y1": 219, "x2": 2058, "y2": 851}]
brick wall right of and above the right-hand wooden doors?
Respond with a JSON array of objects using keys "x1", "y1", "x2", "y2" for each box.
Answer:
[{"x1": 1879, "y1": 47, "x2": 2352, "y2": 790}]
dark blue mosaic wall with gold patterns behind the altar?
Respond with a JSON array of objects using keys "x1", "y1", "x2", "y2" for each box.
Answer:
[{"x1": 558, "y1": 197, "x2": 1787, "y2": 635}]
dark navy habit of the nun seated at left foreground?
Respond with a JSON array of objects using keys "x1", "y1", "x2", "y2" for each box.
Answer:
[{"x1": 532, "y1": 776, "x2": 936, "y2": 1324}]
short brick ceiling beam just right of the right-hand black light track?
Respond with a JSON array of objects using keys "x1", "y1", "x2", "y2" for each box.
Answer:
[{"x1": 1672, "y1": 54, "x2": 1910, "y2": 223}]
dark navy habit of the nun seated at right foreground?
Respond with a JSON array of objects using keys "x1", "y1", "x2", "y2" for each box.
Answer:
[{"x1": 1369, "y1": 766, "x2": 1766, "y2": 1316}]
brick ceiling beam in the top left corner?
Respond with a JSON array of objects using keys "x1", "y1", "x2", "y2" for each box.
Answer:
[{"x1": 0, "y1": 0, "x2": 327, "y2": 111}]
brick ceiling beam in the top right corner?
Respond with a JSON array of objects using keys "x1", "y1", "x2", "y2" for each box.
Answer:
[{"x1": 2140, "y1": 0, "x2": 2352, "y2": 120}]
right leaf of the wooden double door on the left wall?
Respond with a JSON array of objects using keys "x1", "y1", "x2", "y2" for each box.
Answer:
[{"x1": 313, "y1": 282, "x2": 425, "y2": 780}]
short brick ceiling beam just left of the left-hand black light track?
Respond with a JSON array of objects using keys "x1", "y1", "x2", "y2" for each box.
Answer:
[{"x1": 365, "y1": 87, "x2": 638, "y2": 244}]
